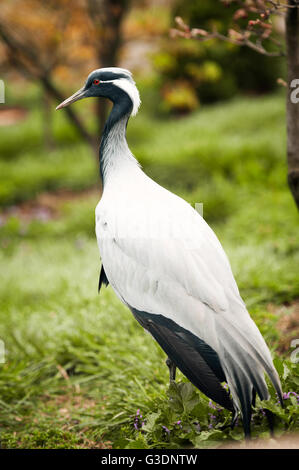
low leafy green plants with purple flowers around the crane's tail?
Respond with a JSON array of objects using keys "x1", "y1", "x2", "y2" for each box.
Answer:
[{"x1": 109, "y1": 358, "x2": 299, "y2": 449}]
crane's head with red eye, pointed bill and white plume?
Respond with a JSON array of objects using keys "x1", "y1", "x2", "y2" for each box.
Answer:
[{"x1": 56, "y1": 67, "x2": 140, "y2": 116}]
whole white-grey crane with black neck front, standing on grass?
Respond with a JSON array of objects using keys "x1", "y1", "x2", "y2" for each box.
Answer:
[{"x1": 56, "y1": 67, "x2": 282, "y2": 436}]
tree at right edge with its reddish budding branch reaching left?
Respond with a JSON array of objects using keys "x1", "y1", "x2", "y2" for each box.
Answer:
[{"x1": 172, "y1": 0, "x2": 299, "y2": 209}]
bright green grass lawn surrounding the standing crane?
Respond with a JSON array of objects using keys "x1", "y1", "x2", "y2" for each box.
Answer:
[{"x1": 0, "y1": 86, "x2": 299, "y2": 448}]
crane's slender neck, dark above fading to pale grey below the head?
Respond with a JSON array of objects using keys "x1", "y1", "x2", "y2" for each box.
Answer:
[{"x1": 100, "y1": 100, "x2": 138, "y2": 187}]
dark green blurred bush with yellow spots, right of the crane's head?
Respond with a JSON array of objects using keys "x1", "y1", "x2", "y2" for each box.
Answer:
[{"x1": 153, "y1": 0, "x2": 283, "y2": 112}]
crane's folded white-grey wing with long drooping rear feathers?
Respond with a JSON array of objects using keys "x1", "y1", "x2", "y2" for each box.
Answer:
[{"x1": 96, "y1": 187, "x2": 281, "y2": 430}]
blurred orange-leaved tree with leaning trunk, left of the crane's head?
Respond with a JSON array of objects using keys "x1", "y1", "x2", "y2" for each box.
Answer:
[{"x1": 0, "y1": 0, "x2": 94, "y2": 145}]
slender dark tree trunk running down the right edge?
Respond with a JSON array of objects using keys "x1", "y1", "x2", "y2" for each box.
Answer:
[{"x1": 286, "y1": 0, "x2": 299, "y2": 209}]
